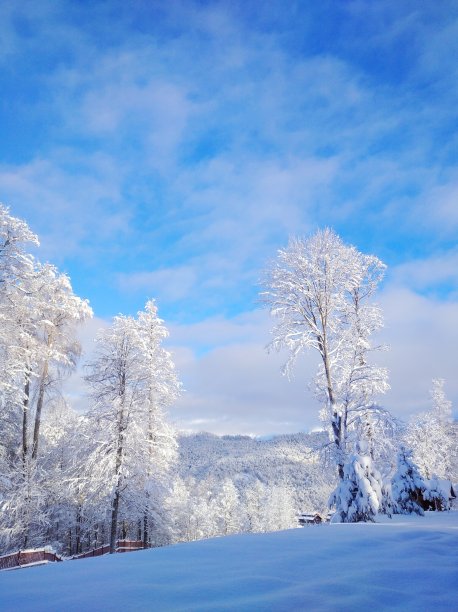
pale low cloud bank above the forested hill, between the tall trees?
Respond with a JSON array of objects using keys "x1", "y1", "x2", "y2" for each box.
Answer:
[{"x1": 171, "y1": 342, "x2": 318, "y2": 434}]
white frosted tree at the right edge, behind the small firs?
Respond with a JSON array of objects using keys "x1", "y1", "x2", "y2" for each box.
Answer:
[{"x1": 406, "y1": 379, "x2": 455, "y2": 479}]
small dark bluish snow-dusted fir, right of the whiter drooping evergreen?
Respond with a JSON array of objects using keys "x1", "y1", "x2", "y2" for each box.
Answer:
[{"x1": 391, "y1": 446, "x2": 426, "y2": 514}]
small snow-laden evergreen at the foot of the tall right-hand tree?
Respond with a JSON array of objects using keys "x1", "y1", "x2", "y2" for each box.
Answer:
[{"x1": 329, "y1": 441, "x2": 382, "y2": 523}]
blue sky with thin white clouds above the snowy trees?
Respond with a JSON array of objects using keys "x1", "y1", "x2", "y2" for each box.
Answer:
[{"x1": 0, "y1": 0, "x2": 458, "y2": 433}]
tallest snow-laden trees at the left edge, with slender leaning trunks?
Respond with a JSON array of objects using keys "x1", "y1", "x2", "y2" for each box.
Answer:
[{"x1": 0, "y1": 206, "x2": 92, "y2": 547}]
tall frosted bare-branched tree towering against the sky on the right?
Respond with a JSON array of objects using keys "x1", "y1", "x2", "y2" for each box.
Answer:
[{"x1": 261, "y1": 229, "x2": 388, "y2": 478}]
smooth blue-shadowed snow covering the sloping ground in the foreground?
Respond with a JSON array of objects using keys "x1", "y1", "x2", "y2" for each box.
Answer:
[{"x1": 0, "y1": 512, "x2": 458, "y2": 612}]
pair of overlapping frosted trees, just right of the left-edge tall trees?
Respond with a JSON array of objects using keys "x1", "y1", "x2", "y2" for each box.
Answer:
[{"x1": 86, "y1": 302, "x2": 178, "y2": 552}]
